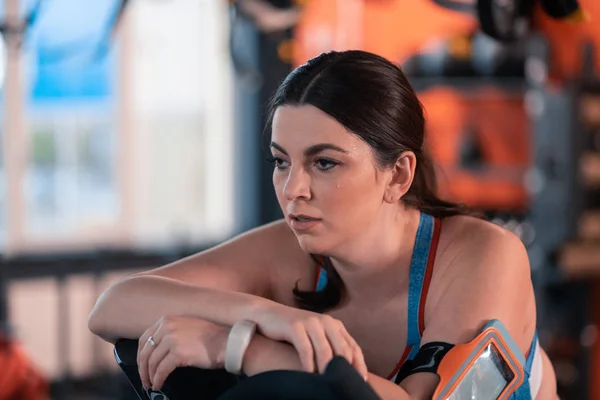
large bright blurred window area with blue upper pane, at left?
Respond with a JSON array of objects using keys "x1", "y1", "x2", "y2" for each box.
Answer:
[{"x1": 0, "y1": 0, "x2": 234, "y2": 253}]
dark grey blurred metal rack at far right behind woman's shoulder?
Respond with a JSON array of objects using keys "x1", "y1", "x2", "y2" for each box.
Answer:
[{"x1": 526, "y1": 36, "x2": 600, "y2": 399}]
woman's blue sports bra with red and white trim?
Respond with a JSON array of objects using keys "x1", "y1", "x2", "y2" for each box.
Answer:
[{"x1": 315, "y1": 212, "x2": 542, "y2": 400}]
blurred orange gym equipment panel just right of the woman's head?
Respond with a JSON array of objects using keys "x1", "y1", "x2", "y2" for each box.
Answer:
[{"x1": 419, "y1": 86, "x2": 531, "y2": 212}]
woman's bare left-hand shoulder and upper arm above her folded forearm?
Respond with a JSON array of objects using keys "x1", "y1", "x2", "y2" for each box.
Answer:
[{"x1": 137, "y1": 220, "x2": 310, "y2": 300}]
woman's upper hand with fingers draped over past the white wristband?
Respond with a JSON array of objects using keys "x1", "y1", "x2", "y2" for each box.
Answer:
[{"x1": 252, "y1": 303, "x2": 368, "y2": 380}]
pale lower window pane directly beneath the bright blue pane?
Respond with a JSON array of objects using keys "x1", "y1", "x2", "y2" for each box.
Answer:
[{"x1": 25, "y1": 115, "x2": 119, "y2": 239}]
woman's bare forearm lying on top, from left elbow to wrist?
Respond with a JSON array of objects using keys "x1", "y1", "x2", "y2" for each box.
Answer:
[{"x1": 88, "y1": 275, "x2": 270, "y2": 341}]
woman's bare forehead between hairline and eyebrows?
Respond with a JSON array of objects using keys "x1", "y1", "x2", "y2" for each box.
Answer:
[{"x1": 272, "y1": 105, "x2": 367, "y2": 147}]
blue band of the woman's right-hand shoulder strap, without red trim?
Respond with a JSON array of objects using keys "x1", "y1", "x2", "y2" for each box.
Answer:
[{"x1": 406, "y1": 213, "x2": 434, "y2": 359}]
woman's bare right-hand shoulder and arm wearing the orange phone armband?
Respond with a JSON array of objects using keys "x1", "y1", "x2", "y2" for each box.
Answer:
[{"x1": 401, "y1": 222, "x2": 536, "y2": 399}]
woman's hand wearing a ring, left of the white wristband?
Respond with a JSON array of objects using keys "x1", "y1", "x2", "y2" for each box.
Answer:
[{"x1": 137, "y1": 317, "x2": 229, "y2": 390}]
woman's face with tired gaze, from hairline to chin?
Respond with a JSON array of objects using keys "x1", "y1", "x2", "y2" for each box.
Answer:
[{"x1": 271, "y1": 105, "x2": 389, "y2": 254}]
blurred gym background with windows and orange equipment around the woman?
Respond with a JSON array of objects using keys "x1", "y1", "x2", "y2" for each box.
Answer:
[{"x1": 0, "y1": 0, "x2": 600, "y2": 400}]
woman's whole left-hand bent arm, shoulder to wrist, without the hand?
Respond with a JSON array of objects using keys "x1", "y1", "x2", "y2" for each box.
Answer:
[{"x1": 88, "y1": 223, "x2": 297, "y2": 341}]
